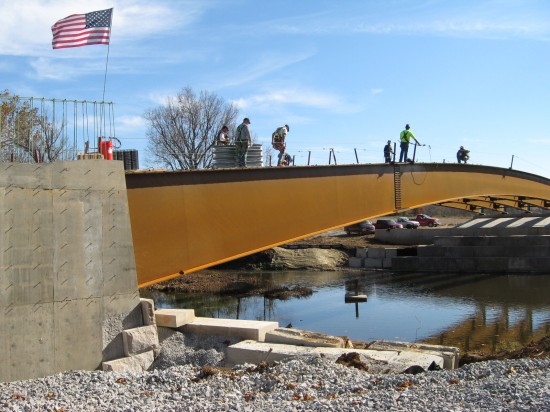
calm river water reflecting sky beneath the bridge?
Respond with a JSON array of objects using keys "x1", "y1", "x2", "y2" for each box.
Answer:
[{"x1": 144, "y1": 271, "x2": 550, "y2": 352}]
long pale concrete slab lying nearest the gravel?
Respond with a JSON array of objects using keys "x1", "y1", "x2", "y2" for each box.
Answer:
[{"x1": 226, "y1": 340, "x2": 445, "y2": 373}]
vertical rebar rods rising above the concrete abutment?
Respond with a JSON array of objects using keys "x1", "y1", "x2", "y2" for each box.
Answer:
[{"x1": 0, "y1": 92, "x2": 116, "y2": 163}]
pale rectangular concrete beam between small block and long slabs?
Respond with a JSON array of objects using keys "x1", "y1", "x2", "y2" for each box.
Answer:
[{"x1": 183, "y1": 317, "x2": 279, "y2": 341}]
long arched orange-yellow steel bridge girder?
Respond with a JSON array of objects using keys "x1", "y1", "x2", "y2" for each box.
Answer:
[{"x1": 126, "y1": 163, "x2": 550, "y2": 286}]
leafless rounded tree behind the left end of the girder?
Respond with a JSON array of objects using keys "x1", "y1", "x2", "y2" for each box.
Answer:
[{"x1": 145, "y1": 87, "x2": 238, "y2": 170}]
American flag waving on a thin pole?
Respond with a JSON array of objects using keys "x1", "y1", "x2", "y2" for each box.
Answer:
[{"x1": 52, "y1": 9, "x2": 113, "y2": 49}]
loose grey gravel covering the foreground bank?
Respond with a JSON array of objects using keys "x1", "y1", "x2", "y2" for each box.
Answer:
[{"x1": 0, "y1": 334, "x2": 550, "y2": 412}]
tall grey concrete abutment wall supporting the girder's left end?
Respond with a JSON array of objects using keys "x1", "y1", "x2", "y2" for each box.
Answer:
[{"x1": 0, "y1": 160, "x2": 143, "y2": 381}]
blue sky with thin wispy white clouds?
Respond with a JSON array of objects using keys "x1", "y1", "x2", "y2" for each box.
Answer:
[{"x1": 0, "y1": 0, "x2": 550, "y2": 177}]
